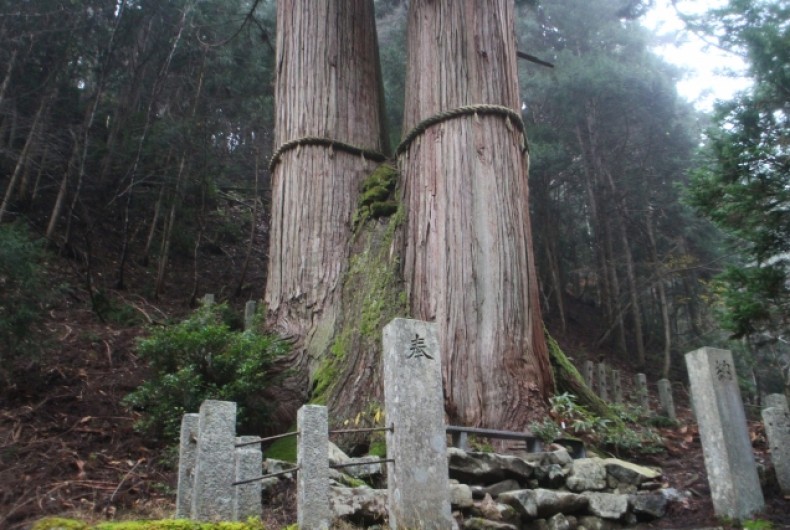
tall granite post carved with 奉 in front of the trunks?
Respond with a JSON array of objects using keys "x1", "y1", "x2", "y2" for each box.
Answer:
[{"x1": 383, "y1": 318, "x2": 454, "y2": 530}]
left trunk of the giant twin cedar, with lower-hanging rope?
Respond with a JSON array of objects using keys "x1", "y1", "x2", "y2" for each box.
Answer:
[{"x1": 265, "y1": 0, "x2": 386, "y2": 421}]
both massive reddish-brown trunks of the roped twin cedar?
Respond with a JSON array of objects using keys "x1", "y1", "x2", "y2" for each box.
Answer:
[{"x1": 265, "y1": 0, "x2": 552, "y2": 428}]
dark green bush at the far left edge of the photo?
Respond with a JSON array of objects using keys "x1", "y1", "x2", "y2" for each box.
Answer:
[{"x1": 0, "y1": 224, "x2": 46, "y2": 365}]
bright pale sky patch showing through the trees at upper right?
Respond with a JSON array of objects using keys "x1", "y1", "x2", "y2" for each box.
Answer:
[{"x1": 643, "y1": 0, "x2": 751, "y2": 110}]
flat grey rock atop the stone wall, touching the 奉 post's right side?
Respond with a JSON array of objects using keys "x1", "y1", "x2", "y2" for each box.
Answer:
[{"x1": 447, "y1": 447, "x2": 535, "y2": 484}]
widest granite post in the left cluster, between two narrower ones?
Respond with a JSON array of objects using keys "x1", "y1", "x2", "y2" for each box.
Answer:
[{"x1": 190, "y1": 400, "x2": 236, "y2": 521}]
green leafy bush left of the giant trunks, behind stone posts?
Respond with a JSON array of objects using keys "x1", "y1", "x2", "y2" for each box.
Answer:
[{"x1": 124, "y1": 304, "x2": 288, "y2": 440}]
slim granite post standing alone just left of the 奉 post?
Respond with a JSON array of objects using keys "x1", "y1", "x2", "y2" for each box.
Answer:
[{"x1": 296, "y1": 405, "x2": 332, "y2": 530}]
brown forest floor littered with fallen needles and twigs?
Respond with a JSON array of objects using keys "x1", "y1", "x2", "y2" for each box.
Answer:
[{"x1": 0, "y1": 245, "x2": 790, "y2": 530}]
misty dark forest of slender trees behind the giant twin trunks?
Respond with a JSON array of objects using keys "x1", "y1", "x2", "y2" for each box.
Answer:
[{"x1": 0, "y1": 0, "x2": 790, "y2": 524}]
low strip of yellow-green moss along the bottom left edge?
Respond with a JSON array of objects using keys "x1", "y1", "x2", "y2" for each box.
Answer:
[{"x1": 31, "y1": 517, "x2": 264, "y2": 530}]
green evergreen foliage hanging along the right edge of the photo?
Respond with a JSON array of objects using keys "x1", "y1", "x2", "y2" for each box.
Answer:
[{"x1": 689, "y1": 0, "x2": 790, "y2": 353}]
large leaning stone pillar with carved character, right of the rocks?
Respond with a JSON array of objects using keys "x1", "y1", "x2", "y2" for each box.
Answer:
[{"x1": 686, "y1": 348, "x2": 765, "y2": 520}]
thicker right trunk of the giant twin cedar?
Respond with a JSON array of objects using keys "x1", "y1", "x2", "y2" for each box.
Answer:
[{"x1": 399, "y1": 0, "x2": 552, "y2": 429}]
